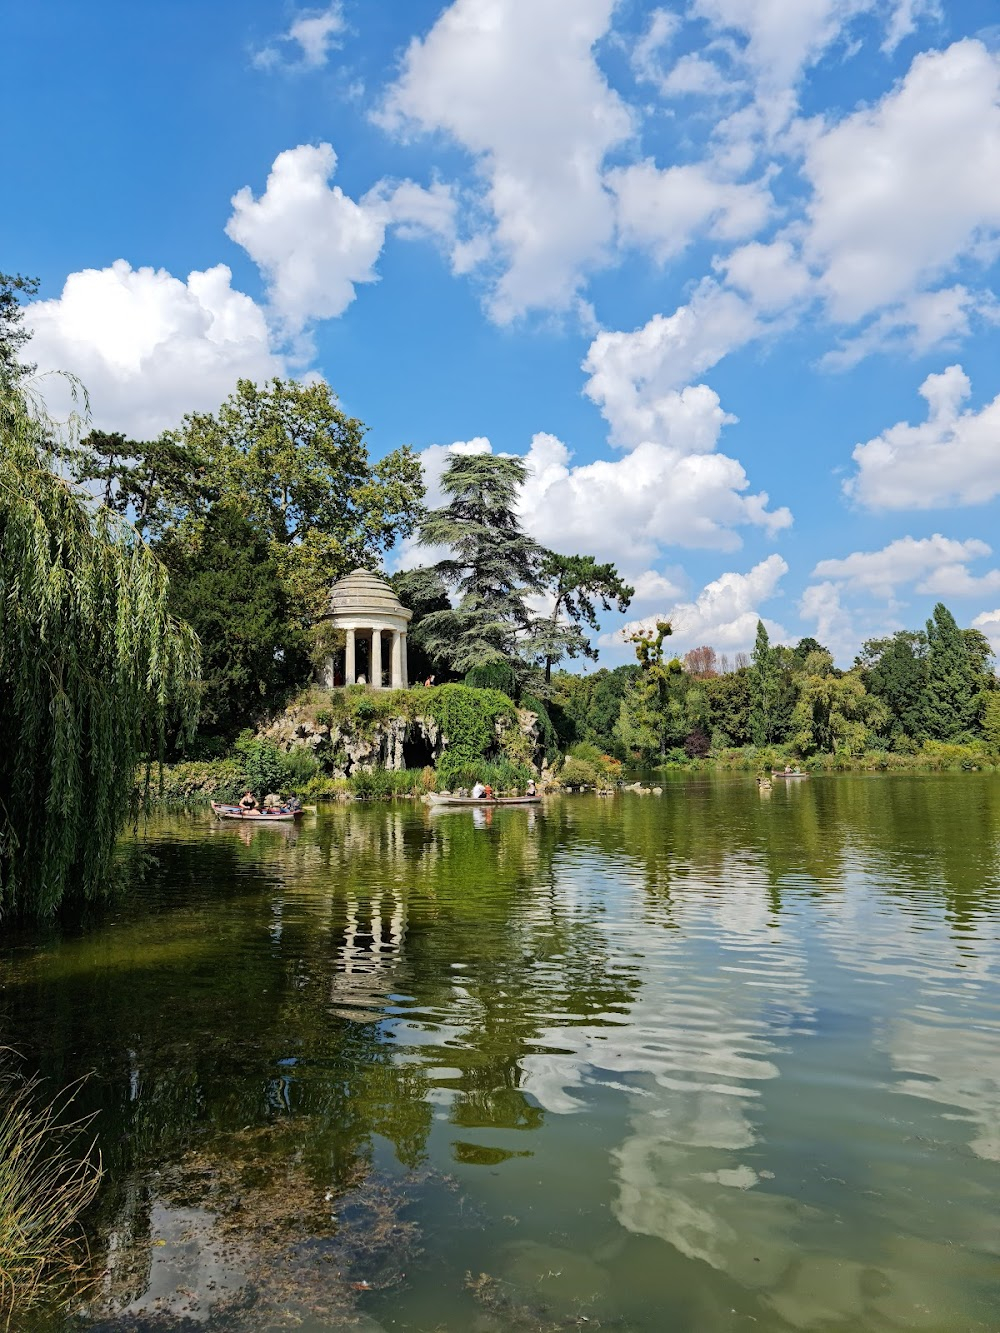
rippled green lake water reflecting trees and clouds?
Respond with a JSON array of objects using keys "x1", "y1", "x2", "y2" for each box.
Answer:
[{"x1": 0, "y1": 774, "x2": 1000, "y2": 1333}]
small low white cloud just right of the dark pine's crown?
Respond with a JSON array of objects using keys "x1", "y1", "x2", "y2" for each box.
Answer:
[{"x1": 601, "y1": 556, "x2": 788, "y2": 652}]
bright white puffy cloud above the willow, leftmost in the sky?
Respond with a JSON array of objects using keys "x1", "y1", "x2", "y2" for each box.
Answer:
[{"x1": 25, "y1": 259, "x2": 288, "y2": 439}]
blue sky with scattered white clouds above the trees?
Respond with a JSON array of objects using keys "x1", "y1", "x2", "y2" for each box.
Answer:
[{"x1": 0, "y1": 0, "x2": 1000, "y2": 667}]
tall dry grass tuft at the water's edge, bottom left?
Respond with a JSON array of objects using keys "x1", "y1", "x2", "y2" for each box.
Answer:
[{"x1": 0, "y1": 1050, "x2": 101, "y2": 1333}]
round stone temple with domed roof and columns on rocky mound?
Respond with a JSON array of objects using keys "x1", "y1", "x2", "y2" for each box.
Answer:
[{"x1": 325, "y1": 569, "x2": 413, "y2": 689}]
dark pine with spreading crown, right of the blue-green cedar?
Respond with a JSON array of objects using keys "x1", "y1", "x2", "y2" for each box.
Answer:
[{"x1": 527, "y1": 551, "x2": 635, "y2": 685}]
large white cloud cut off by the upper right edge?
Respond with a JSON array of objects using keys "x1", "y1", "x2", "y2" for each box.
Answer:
[{"x1": 804, "y1": 40, "x2": 1000, "y2": 321}]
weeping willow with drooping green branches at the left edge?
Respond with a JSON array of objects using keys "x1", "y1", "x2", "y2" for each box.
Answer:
[{"x1": 0, "y1": 379, "x2": 197, "y2": 916}]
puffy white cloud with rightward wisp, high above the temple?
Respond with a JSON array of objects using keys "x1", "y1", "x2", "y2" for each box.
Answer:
[{"x1": 225, "y1": 144, "x2": 455, "y2": 333}]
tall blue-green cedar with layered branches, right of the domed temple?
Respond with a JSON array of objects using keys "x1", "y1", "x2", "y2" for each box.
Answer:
[{"x1": 420, "y1": 453, "x2": 543, "y2": 674}]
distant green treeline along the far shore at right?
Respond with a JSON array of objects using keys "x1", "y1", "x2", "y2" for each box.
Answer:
[{"x1": 549, "y1": 603, "x2": 1000, "y2": 764}]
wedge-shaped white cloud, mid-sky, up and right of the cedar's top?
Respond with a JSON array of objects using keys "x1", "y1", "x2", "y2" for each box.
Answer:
[{"x1": 584, "y1": 280, "x2": 761, "y2": 452}]
